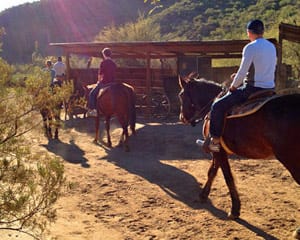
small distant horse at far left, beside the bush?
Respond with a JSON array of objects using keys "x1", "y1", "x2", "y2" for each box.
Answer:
[{"x1": 40, "y1": 82, "x2": 63, "y2": 139}]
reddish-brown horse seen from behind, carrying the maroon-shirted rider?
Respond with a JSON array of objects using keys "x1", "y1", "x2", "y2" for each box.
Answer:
[{"x1": 87, "y1": 82, "x2": 136, "y2": 152}]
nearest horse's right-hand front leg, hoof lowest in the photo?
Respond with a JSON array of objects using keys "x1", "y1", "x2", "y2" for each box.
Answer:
[{"x1": 214, "y1": 149, "x2": 241, "y2": 219}]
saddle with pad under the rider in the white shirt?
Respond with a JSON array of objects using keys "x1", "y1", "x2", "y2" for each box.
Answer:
[{"x1": 226, "y1": 90, "x2": 279, "y2": 118}]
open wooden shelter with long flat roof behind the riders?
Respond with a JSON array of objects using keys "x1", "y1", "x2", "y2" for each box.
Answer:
[{"x1": 50, "y1": 39, "x2": 278, "y2": 114}]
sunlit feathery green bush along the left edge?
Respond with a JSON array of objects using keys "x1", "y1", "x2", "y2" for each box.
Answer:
[{"x1": 0, "y1": 30, "x2": 65, "y2": 239}]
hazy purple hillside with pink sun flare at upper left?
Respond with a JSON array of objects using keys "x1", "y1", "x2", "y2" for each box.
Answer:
[{"x1": 0, "y1": 0, "x2": 147, "y2": 63}]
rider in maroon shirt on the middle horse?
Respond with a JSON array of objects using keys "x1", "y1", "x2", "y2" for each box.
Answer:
[{"x1": 87, "y1": 48, "x2": 117, "y2": 117}]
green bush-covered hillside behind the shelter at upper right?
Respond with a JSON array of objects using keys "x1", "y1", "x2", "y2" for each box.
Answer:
[{"x1": 153, "y1": 0, "x2": 300, "y2": 40}]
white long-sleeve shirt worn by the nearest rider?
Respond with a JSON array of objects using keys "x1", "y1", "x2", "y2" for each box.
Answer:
[{"x1": 231, "y1": 38, "x2": 277, "y2": 88}]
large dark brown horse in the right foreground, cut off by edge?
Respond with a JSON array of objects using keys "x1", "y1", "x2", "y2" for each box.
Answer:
[{"x1": 179, "y1": 76, "x2": 300, "y2": 219}]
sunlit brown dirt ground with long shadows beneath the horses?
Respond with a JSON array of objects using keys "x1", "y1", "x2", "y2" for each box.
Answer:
[{"x1": 3, "y1": 115, "x2": 300, "y2": 240}]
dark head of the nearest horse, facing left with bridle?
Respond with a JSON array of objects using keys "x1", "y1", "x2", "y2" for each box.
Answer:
[{"x1": 179, "y1": 76, "x2": 222, "y2": 126}]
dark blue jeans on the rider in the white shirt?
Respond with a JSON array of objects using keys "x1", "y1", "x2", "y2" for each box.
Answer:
[{"x1": 209, "y1": 85, "x2": 272, "y2": 138}]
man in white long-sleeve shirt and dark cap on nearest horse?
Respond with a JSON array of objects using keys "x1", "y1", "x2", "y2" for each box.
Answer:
[{"x1": 196, "y1": 19, "x2": 276, "y2": 152}]
